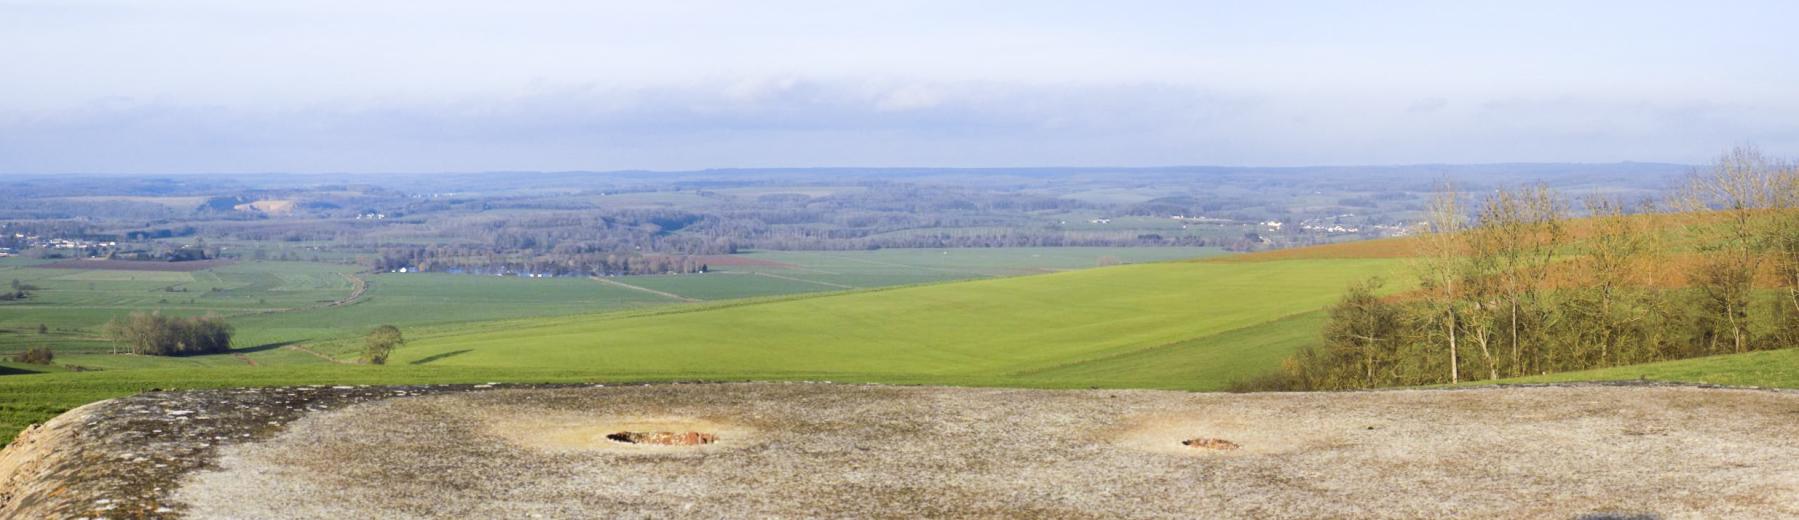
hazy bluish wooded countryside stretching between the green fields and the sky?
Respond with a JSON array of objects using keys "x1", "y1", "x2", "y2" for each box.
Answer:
[{"x1": 0, "y1": 164, "x2": 1686, "y2": 275}]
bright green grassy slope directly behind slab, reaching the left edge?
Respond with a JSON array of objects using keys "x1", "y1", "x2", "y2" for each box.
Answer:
[{"x1": 0, "y1": 259, "x2": 1396, "y2": 435}]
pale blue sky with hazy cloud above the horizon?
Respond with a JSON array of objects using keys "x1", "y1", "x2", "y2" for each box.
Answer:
[{"x1": 0, "y1": 0, "x2": 1799, "y2": 173}]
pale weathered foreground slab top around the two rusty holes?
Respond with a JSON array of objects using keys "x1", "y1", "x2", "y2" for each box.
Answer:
[{"x1": 151, "y1": 383, "x2": 1799, "y2": 518}]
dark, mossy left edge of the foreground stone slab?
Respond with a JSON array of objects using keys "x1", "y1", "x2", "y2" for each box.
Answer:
[{"x1": 0, "y1": 377, "x2": 539, "y2": 518}]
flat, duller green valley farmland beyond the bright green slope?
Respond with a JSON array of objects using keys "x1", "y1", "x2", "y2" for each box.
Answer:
[{"x1": 0, "y1": 248, "x2": 1218, "y2": 363}]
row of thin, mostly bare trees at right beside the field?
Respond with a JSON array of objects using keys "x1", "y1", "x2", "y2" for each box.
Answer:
[{"x1": 1238, "y1": 149, "x2": 1799, "y2": 390}]
